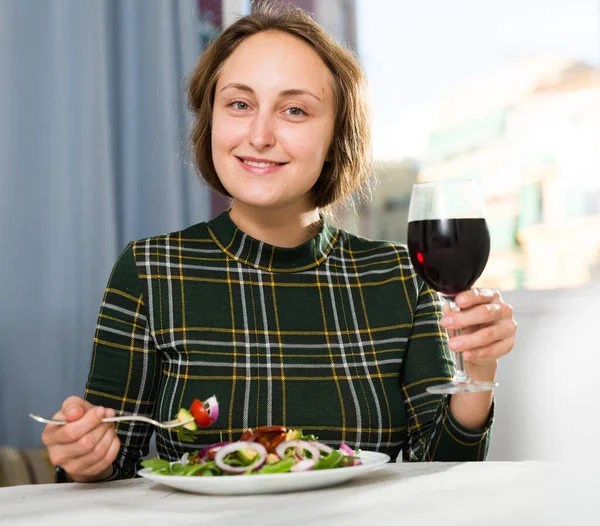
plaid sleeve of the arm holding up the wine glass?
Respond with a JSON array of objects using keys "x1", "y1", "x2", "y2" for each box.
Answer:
[{"x1": 401, "y1": 282, "x2": 493, "y2": 461}]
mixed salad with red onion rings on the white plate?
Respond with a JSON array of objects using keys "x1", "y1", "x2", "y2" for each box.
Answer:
[{"x1": 142, "y1": 424, "x2": 361, "y2": 477}]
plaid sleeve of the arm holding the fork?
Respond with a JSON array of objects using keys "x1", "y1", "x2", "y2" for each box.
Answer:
[{"x1": 85, "y1": 244, "x2": 161, "y2": 478}]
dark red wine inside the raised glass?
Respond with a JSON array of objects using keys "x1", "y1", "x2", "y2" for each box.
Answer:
[{"x1": 408, "y1": 219, "x2": 490, "y2": 296}]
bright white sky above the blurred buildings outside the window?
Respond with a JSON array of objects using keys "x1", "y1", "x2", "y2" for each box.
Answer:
[{"x1": 357, "y1": 0, "x2": 600, "y2": 160}]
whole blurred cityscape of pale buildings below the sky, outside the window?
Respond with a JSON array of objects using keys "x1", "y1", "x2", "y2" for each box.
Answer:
[{"x1": 419, "y1": 58, "x2": 600, "y2": 290}]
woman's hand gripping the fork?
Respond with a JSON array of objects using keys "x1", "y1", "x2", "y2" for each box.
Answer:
[{"x1": 42, "y1": 396, "x2": 121, "y2": 482}]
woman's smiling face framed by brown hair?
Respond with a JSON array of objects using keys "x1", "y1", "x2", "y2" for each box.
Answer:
[{"x1": 212, "y1": 31, "x2": 335, "y2": 211}]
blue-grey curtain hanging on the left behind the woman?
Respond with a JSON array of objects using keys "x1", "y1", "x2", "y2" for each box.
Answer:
[{"x1": 0, "y1": 0, "x2": 209, "y2": 447}]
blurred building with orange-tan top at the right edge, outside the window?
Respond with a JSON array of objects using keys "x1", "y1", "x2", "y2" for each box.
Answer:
[{"x1": 508, "y1": 64, "x2": 600, "y2": 288}]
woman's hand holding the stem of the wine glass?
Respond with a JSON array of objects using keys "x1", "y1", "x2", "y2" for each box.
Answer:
[{"x1": 441, "y1": 288, "x2": 517, "y2": 373}]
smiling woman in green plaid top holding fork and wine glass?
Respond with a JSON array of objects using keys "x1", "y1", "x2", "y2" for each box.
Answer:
[{"x1": 43, "y1": 7, "x2": 516, "y2": 482}]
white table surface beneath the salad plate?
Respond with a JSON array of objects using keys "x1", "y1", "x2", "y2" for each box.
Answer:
[{"x1": 0, "y1": 462, "x2": 600, "y2": 526}]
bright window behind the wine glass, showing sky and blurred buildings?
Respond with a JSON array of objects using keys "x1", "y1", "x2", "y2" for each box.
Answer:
[{"x1": 357, "y1": 0, "x2": 600, "y2": 289}]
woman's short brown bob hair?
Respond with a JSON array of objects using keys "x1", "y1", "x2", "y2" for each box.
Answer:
[{"x1": 187, "y1": 2, "x2": 372, "y2": 208}]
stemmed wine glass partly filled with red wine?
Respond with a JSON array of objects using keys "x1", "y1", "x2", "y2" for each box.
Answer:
[{"x1": 408, "y1": 179, "x2": 498, "y2": 394}]
